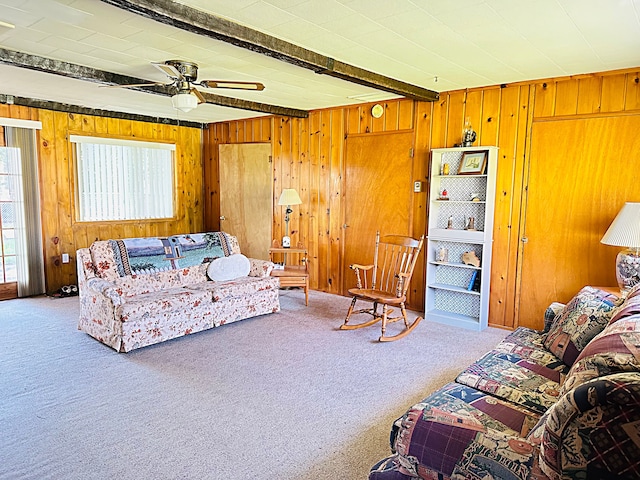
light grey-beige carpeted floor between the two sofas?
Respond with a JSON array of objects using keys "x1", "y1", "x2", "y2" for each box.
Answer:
[{"x1": 0, "y1": 290, "x2": 507, "y2": 480}]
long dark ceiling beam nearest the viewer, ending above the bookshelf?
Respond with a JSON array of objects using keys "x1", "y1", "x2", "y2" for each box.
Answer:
[{"x1": 102, "y1": 0, "x2": 439, "y2": 102}]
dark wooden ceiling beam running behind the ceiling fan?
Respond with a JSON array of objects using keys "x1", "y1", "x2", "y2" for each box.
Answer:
[{"x1": 0, "y1": 48, "x2": 309, "y2": 118}]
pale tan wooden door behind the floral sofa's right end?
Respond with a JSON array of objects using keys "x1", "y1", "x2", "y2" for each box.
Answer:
[{"x1": 219, "y1": 143, "x2": 273, "y2": 260}]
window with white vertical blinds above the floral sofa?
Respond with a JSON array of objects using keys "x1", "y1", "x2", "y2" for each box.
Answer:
[{"x1": 71, "y1": 135, "x2": 175, "y2": 222}]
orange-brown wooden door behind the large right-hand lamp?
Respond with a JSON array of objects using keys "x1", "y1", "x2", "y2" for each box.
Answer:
[{"x1": 518, "y1": 115, "x2": 640, "y2": 328}]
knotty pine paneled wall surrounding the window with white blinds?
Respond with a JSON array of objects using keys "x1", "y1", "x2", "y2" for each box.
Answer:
[{"x1": 0, "y1": 105, "x2": 204, "y2": 292}]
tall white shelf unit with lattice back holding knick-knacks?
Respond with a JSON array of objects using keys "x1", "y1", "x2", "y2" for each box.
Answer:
[{"x1": 425, "y1": 147, "x2": 498, "y2": 330}]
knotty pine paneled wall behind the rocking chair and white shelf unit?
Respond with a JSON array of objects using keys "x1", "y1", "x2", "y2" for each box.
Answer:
[{"x1": 205, "y1": 69, "x2": 640, "y2": 328}]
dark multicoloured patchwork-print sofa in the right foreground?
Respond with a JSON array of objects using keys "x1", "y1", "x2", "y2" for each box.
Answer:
[{"x1": 369, "y1": 286, "x2": 640, "y2": 480}]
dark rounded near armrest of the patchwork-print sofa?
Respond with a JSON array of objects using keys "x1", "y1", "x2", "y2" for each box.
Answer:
[{"x1": 528, "y1": 372, "x2": 640, "y2": 479}]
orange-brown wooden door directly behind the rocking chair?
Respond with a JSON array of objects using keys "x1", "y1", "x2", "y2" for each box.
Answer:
[{"x1": 342, "y1": 132, "x2": 413, "y2": 294}]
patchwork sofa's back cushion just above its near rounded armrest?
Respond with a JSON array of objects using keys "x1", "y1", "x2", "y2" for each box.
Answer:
[{"x1": 560, "y1": 315, "x2": 640, "y2": 395}]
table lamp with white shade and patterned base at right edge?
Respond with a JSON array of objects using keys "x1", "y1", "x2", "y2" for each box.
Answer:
[{"x1": 600, "y1": 202, "x2": 640, "y2": 295}]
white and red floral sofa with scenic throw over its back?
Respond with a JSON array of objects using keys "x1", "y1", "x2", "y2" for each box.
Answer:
[{"x1": 77, "y1": 232, "x2": 280, "y2": 352}]
